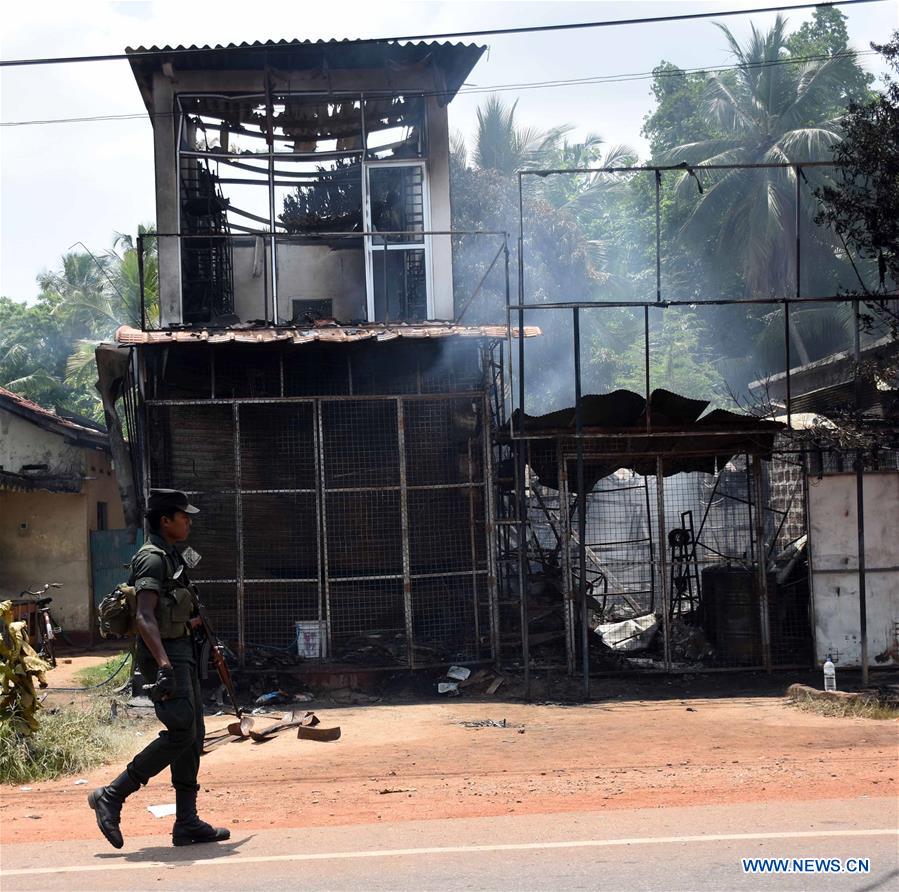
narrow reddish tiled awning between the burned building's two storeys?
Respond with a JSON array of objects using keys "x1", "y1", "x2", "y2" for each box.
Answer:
[{"x1": 115, "y1": 322, "x2": 541, "y2": 346}]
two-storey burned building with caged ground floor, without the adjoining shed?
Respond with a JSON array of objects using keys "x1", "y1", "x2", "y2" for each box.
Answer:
[{"x1": 99, "y1": 41, "x2": 536, "y2": 667}]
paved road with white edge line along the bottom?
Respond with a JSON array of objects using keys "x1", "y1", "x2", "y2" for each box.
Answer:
[{"x1": 0, "y1": 798, "x2": 899, "y2": 892}]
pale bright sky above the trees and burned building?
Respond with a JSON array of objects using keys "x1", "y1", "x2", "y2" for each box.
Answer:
[{"x1": 0, "y1": 0, "x2": 899, "y2": 301}]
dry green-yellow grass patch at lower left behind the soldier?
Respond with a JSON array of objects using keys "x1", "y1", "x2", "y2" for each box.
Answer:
[{"x1": 0, "y1": 697, "x2": 137, "y2": 784}]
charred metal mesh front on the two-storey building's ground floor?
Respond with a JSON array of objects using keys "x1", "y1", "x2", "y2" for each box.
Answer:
[{"x1": 145, "y1": 341, "x2": 496, "y2": 666}]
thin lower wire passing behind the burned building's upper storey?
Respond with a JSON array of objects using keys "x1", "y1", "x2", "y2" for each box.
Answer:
[{"x1": 0, "y1": 50, "x2": 877, "y2": 127}]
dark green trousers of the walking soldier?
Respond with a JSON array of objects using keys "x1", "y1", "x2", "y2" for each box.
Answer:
[{"x1": 128, "y1": 636, "x2": 206, "y2": 790}]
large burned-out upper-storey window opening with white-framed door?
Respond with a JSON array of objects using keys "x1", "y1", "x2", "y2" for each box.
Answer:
[{"x1": 179, "y1": 92, "x2": 429, "y2": 323}]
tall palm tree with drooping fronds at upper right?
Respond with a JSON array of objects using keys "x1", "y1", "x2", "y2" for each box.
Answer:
[{"x1": 660, "y1": 16, "x2": 848, "y2": 297}]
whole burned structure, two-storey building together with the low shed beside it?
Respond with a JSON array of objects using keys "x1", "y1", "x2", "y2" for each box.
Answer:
[{"x1": 98, "y1": 41, "x2": 880, "y2": 690}]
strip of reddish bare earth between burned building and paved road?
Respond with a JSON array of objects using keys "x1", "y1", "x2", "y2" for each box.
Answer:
[{"x1": 0, "y1": 656, "x2": 899, "y2": 845}]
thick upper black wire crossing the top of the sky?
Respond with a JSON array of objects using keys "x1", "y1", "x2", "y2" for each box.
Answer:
[{"x1": 0, "y1": 0, "x2": 886, "y2": 68}]
